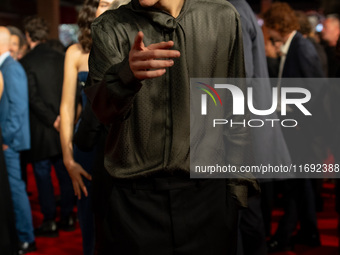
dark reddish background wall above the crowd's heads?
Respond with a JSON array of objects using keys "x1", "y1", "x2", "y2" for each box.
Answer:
[{"x1": 0, "y1": 0, "x2": 340, "y2": 38}]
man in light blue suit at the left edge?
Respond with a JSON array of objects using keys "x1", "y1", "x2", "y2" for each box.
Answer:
[{"x1": 0, "y1": 27, "x2": 36, "y2": 254}]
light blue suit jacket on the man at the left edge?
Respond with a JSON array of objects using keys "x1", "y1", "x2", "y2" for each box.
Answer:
[{"x1": 0, "y1": 56, "x2": 30, "y2": 151}]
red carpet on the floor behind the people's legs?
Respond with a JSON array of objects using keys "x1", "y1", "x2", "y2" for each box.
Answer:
[{"x1": 27, "y1": 164, "x2": 340, "y2": 255}]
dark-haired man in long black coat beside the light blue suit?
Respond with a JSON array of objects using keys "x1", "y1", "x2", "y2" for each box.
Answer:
[{"x1": 21, "y1": 17, "x2": 74, "y2": 237}]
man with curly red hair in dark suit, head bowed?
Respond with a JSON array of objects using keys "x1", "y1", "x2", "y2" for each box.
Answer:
[{"x1": 264, "y1": 3, "x2": 327, "y2": 252}]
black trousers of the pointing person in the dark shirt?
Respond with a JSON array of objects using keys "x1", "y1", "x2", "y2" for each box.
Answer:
[{"x1": 96, "y1": 177, "x2": 238, "y2": 255}]
